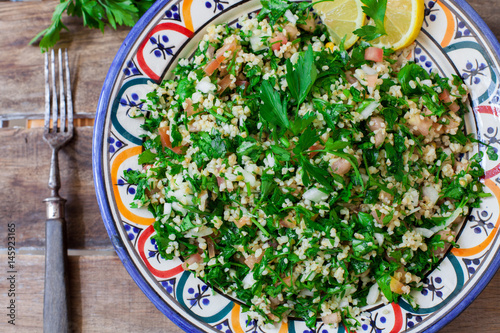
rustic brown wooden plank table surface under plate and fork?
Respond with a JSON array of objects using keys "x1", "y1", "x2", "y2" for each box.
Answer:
[{"x1": 0, "y1": 0, "x2": 500, "y2": 333}]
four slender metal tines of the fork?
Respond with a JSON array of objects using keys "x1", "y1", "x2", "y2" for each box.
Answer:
[{"x1": 45, "y1": 49, "x2": 73, "y2": 133}]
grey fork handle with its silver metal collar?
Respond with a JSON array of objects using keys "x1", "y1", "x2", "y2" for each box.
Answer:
[{"x1": 43, "y1": 197, "x2": 68, "y2": 333}]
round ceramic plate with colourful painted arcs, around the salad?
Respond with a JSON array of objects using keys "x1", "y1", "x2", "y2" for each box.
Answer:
[{"x1": 93, "y1": 0, "x2": 500, "y2": 333}]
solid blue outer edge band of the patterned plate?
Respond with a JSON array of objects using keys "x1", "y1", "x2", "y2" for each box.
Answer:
[{"x1": 92, "y1": 0, "x2": 500, "y2": 332}]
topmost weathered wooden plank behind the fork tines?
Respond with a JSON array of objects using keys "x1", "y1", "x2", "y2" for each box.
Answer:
[{"x1": 0, "y1": 0, "x2": 130, "y2": 115}]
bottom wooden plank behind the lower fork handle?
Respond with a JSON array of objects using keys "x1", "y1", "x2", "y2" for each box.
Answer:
[{"x1": 0, "y1": 255, "x2": 182, "y2": 333}]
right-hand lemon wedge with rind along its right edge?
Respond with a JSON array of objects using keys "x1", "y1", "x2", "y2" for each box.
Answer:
[{"x1": 370, "y1": 0, "x2": 425, "y2": 50}]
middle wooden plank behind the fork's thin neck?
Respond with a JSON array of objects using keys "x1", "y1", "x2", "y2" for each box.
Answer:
[{"x1": 0, "y1": 127, "x2": 111, "y2": 249}]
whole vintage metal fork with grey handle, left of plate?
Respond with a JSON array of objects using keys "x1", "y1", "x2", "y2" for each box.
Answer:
[{"x1": 43, "y1": 49, "x2": 73, "y2": 333}]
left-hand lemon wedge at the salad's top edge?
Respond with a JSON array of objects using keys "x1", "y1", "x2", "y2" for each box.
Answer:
[{"x1": 313, "y1": 0, "x2": 366, "y2": 49}]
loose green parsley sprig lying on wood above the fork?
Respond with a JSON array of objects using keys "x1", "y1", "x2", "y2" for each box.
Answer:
[{"x1": 30, "y1": 0, "x2": 155, "y2": 51}]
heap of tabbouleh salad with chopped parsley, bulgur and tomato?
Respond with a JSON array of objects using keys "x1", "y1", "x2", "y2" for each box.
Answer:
[{"x1": 125, "y1": 3, "x2": 494, "y2": 329}]
